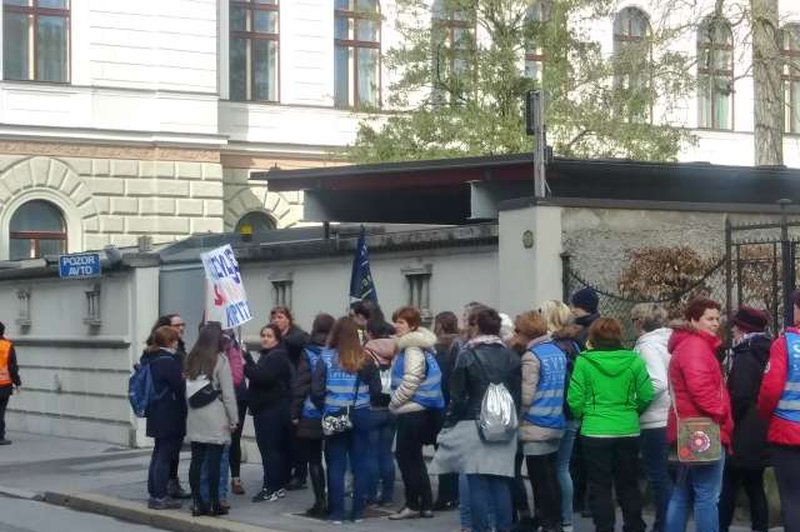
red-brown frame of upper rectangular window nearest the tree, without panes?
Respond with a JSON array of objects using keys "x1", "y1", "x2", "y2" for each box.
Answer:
[{"x1": 333, "y1": 0, "x2": 383, "y2": 109}]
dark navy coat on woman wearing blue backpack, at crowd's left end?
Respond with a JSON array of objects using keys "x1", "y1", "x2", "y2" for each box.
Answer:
[{"x1": 140, "y1": 349, "x2": 186, "y2": 438}]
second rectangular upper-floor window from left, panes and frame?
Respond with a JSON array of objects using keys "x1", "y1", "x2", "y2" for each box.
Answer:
[{"x1": 230, "y1": 0, "x2": 280, "y2": 102}]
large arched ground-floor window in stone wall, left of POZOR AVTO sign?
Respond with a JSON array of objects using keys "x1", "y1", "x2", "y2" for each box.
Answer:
[{"x1": 9, "y1": 200, "x2": 67, "y2": 260}]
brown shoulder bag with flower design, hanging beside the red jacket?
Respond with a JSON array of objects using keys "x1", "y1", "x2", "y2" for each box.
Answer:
[{"x1": 670, "y1": 384, "x2": 722, "y2": 466}]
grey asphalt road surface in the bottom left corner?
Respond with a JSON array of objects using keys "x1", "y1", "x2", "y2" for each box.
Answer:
[{"x1": 0, "y1": 497, "x2": 166, "y2": 532}]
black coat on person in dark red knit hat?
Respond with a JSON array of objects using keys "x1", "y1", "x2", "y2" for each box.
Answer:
[{"x1": 728, "y1": 335, "x2": 772, "y2": 469}]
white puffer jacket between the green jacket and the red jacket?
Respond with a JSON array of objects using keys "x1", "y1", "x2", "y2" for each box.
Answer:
[{"x1": 633, "y1": 327, "x2": 672, "y2": 429}]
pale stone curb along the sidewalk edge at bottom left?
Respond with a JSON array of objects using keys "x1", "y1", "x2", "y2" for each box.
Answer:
[{"x1": 40, "y1": 491, "x2": 280, "y2": 532}]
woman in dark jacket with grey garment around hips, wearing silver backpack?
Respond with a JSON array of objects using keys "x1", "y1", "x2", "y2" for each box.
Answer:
[{"x1": 432, "y1": 307, "x2": 521, "y2": 532}]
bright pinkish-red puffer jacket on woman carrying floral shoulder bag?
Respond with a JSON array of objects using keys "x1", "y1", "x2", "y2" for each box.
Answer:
[{"x1": 667, "y1": 324, "x2": 733, "y2": 448}]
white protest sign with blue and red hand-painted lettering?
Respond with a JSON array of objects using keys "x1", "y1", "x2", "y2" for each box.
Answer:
[{"x1": 200, "y1": 244, "x2": 253, "y2": 329}]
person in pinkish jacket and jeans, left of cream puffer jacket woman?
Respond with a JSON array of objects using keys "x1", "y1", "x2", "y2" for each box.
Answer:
[{"x1": 364, "y1": 317, "x2": 397, "y2": 506}]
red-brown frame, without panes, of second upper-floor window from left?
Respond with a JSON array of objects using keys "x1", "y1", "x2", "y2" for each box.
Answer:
[{"x1": 228, "y1": 0, "x2": 282, "y2": 104}]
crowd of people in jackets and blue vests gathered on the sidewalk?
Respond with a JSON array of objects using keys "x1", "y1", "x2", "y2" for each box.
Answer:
[{"x1": 142, "y1": 288, "x2": 800, "y2": 532}]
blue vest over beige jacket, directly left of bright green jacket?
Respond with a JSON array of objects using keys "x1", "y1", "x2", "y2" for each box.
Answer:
[{"x1": 525, "y1": 342, "x2": 567, "y2": 430}]
